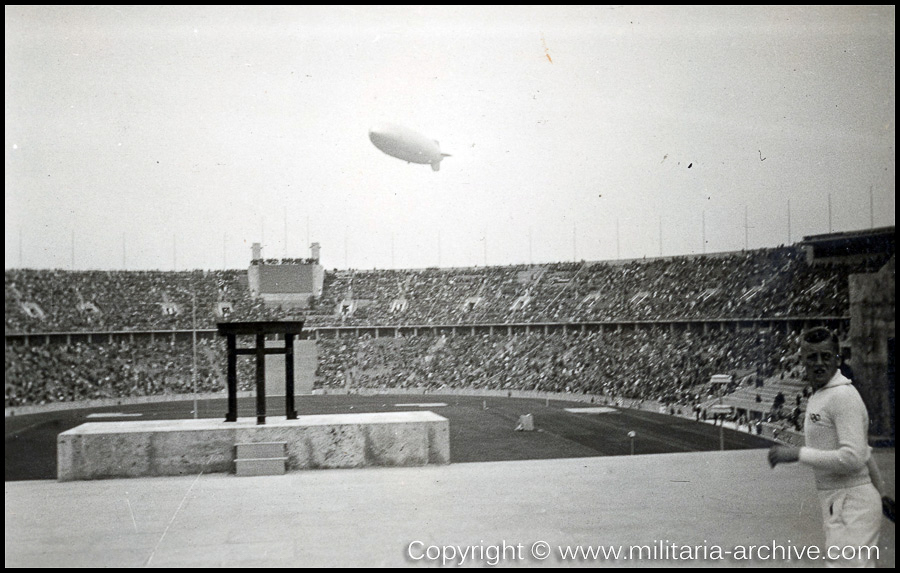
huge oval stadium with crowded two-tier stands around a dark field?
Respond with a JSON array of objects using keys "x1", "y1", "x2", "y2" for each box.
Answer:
[{"x1": 5, "y1": 229, "x2": 893, "y2": 564}]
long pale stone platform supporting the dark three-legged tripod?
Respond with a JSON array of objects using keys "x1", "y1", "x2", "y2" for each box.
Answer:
[{"x1": 57, "y1": 411, "x2": 450, "y2": 481}]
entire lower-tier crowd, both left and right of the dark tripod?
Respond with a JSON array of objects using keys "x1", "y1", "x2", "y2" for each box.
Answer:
[{"x1": 5, "y1": 328, "x2": 795, "y2": 407}]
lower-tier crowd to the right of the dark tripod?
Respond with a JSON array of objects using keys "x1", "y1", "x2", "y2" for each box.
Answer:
[{"x1": 317, "y1": 328, "x2": 792, "y2": 404}]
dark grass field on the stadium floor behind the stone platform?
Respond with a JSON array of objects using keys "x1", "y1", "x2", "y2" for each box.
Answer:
[{"x1": 4, "y1": 394, "x2": 770, "y2": 481}]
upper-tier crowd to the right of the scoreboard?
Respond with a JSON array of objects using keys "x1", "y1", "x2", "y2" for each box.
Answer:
[{"x1": 308, "y1": 247, "x2": 884, "y2": 326}]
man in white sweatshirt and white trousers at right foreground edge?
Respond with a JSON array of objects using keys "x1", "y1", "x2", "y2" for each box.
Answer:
[{"x1": 769, "y1": 327, "x2": 881, "y2": 567}]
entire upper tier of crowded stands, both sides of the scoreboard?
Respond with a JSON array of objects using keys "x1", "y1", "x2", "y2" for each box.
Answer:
[{"x1": 5, "y1": 246, "x2": 892, "y2": 335}]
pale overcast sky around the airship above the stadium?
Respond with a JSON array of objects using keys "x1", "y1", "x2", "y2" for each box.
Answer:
[{"x1": 4, "y1": 6, "x2": 896, "y2": 270}]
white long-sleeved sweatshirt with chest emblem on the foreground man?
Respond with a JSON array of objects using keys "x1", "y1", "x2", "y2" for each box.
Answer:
[{"x1": 800, "y1": 370, "x2": 871, "y2": 490}]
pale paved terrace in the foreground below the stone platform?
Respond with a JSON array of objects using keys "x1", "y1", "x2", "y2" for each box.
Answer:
[{"x1": 5, "y1": 449, "x2": 894, "y2": 567}]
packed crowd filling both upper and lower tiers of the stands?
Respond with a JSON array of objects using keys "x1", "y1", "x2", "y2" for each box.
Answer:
[{"x1": 5, "y1": 247, "x2": 883, "y2": 407}]
